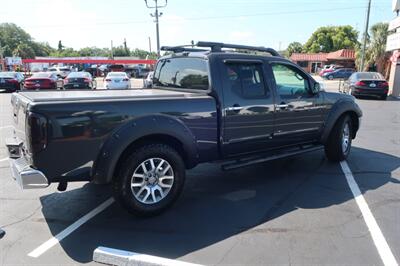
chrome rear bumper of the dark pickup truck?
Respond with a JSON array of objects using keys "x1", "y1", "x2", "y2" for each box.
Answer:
[{"x1": 9, "y1": 157, "x2": 49, "y2": 189}]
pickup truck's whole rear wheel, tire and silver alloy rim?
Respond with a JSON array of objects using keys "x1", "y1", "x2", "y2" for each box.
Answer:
[{"x1": 113, "y1": 144, "x2": 185, "y2": 216}]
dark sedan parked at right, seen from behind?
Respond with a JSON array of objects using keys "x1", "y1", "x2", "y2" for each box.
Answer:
[{"x1": 343, "y1": 72, "x2": 389, "y2": 100}]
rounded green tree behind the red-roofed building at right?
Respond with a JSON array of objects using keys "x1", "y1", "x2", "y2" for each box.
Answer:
[{"x1": 303, "y1": 25, "x2": 358, "y2": 53}]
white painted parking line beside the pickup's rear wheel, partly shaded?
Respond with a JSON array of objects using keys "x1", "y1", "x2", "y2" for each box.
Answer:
[{"x1": 28, "y1": 198, "x2": 114, "y2": 258}]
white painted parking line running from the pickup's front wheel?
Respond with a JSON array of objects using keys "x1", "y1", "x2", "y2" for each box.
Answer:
[{"x1": 340, "y1": 161, "x2": 398, "y2": 266}]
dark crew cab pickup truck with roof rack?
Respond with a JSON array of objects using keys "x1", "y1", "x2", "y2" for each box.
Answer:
[{"x1": 7, "y1": 42, "x2": 362, "y2": 215}]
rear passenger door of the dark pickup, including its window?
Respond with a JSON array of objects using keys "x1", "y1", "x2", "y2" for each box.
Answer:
[{"x1": 220, "y1": 59, "x2": 274, "y2": 156}]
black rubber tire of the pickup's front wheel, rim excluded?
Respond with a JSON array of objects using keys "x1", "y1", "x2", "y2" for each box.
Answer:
[{"x1": 325, "y1": 115, "x2": 353, "y2": 162}]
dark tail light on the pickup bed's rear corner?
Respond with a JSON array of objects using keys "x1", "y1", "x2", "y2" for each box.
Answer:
[{"x1": 26, "y1": 113, "x2": 47, "y2": 153}]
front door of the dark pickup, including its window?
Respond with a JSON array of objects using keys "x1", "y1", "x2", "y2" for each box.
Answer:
[{"x1": 270, "y1": 62, "x2": 324, "y2": 146}]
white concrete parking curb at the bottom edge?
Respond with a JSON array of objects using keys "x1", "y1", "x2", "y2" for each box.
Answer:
[{"x1": 93, "y1": 247, "x2": 201, "y2": 266}]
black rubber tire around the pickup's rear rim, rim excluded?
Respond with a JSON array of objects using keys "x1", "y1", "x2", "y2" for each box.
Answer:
[{"x1": 113, "y1": 144, "x2": 186, "y2": 216}]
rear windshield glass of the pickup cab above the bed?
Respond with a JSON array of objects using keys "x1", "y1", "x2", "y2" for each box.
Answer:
[{"x1": 153, "y1": 58, "x2": 209, "y2": 90}]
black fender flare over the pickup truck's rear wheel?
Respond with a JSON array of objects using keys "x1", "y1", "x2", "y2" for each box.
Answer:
[{"x1": 92, "y1": 114, "x2": 199, "y2": 184}]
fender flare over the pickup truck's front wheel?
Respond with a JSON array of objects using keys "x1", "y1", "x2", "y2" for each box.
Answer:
[{"x1": 320, "y1": 99, "x2": 362, "y2": 144}]
